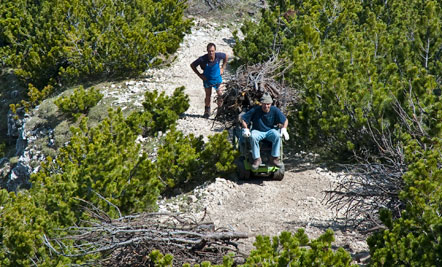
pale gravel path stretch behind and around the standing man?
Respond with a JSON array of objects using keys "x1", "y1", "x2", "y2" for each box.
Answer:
[{"x1": 142, "y1": 19, "x2": 233, "y2": 140}]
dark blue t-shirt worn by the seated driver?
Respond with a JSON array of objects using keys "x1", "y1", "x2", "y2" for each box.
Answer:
[{"x1": 241, "y1": 106, "x2": 287, "y2": 132}]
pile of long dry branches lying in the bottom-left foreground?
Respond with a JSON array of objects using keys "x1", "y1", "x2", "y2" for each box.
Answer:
[{"x1": 44, "y1": 204, "x2": 247, "y2": 266}]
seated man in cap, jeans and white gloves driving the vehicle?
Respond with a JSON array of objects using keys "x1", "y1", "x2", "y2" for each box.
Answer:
[{"x1": 241, "y1": 93, "x2": 289, "y2": 170}]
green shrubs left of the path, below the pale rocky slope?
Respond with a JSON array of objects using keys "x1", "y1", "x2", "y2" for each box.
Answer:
[{"x1": 0, "y1": 88, "x2": 236, "y2": 266}]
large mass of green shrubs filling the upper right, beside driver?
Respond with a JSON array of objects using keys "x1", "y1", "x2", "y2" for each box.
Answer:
[{"x1": 234, "y1": 0, "x2": 442, "y2": 157}]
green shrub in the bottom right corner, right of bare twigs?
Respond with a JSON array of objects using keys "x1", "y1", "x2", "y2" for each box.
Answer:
[{"x1": 367, "y1": 138, "x2": 442, "y2": 266}]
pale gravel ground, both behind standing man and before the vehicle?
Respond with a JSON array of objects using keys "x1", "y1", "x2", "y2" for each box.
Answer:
[{"x1": 143, "y1": 19, "x2": 368, "y2": 262}]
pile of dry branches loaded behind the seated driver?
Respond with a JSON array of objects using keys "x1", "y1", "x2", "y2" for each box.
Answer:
[{"x1": 215, "y1": 56, "x2": 297, "y2": 129}]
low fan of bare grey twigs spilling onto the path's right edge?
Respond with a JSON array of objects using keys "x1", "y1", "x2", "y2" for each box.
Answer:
[{"x1": 324, "y1": 163, "x2": 405, "y2": 231}]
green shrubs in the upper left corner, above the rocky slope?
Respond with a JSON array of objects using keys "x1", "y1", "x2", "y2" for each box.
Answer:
[{"x1": 0, "y1": 0, "x2": 191, "y2": 88}]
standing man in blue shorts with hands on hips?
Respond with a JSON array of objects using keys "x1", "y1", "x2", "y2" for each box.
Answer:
[{"x1": 190, "y1": 43, "x2": 227, "y2": 118}]
